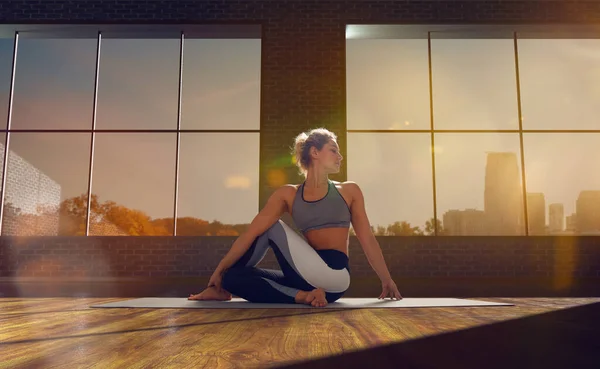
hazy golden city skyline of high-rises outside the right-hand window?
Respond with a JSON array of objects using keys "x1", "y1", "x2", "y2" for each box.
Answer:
[{"x1": 438, "y1": 152, "x2": 600, "y2": 236}]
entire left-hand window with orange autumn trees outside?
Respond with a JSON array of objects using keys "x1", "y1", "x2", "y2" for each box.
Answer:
[{"x1": 0, "y1": 26, "x2": 261, "y2": 236}]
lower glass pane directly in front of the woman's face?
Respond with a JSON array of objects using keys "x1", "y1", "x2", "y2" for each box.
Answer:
[{"x1": 347, "y1": 133, "x2": 434, "y2": 236}]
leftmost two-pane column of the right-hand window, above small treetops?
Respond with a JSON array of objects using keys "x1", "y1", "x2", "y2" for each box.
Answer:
[{"x1": 346, "y1": 40, "x2": 434, "y2": 235}]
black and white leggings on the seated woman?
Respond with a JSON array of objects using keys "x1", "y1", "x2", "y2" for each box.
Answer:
[{"x1": 222, "y1": 220, "x2": 350, "y2": 304}]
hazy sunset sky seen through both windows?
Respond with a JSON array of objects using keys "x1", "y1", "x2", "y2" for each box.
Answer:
[{"x1": 0, "y1": 39, "x2": 600, "y2": 226}]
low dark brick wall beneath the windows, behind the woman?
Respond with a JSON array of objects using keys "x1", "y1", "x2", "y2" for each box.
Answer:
[{"x1": 0, "y1": 236, "x2": 600, "y2": 278}]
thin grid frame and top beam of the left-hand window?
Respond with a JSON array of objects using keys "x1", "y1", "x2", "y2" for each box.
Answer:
[{"x1": 0, "y1": 22, "x2": 264, "y2": 236}]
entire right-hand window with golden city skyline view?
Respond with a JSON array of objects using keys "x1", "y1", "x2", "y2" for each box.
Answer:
[{"x1": 346, "y1": 26, "x2": 600, "y2": 236}]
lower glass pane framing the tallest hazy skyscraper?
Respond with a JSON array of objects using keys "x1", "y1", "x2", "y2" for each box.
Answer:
[{"x1": 435, "y1": 133, "x2": 525, "y2": 236}]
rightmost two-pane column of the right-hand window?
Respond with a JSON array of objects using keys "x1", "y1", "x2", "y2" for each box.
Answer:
[{"x1": 518, "y1": 38, "x2": 600, "y2": 235}]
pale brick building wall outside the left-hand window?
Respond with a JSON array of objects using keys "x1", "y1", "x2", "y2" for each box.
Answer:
[{"x1": 0, "y1": 144, "x2": 61, "y2": 236}]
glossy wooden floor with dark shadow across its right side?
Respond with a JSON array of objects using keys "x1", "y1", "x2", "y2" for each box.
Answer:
[{"x1": 0, "y1": 298, "x2": 600, "y2": 369}]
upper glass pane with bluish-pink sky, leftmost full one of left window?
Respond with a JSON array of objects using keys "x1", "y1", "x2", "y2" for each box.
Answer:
[{"x1": 11, "y1": 38, "x2": 98, "y2": 129}]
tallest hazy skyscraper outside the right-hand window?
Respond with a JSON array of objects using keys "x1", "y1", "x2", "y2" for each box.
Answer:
[{"x1": 484, "y1": 152, "x2": 524, "y2": 235}]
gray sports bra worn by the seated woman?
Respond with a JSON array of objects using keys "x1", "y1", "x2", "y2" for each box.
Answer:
[{"x1": 292, "y1": 180, "x2": 352, "y2": 233}]
